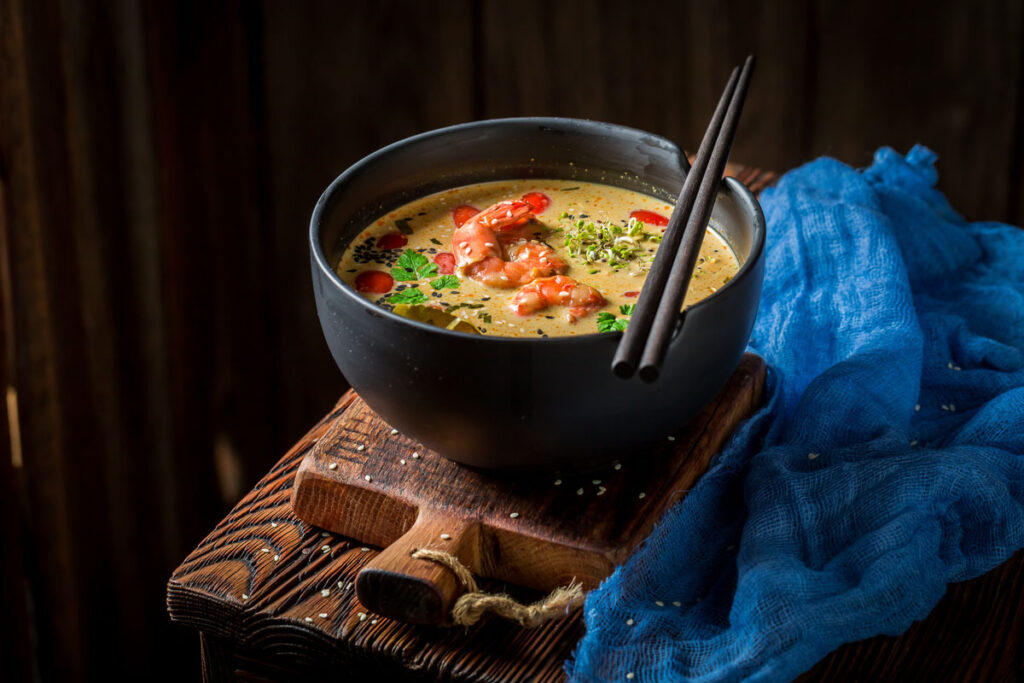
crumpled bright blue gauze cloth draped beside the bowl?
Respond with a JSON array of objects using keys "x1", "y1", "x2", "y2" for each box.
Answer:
[{"x1": 566, "y1": 146, "x2": 1024, "y2": 682}]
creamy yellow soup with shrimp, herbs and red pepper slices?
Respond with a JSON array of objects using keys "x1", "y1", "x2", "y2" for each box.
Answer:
[{"x1": 337, "y1": 179, "x2": 738, "y2": 337}]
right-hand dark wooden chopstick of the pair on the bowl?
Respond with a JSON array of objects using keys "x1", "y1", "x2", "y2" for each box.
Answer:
[{"x1": 627, "y1": 55, "x2": 754, "y2": 382}]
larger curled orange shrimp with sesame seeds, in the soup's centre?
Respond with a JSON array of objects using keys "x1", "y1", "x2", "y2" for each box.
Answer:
[{"x1": 452, "y1": 201, "x2": 568, "y2": 288}]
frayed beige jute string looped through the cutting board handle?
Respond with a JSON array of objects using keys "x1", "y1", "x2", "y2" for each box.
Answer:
[{"x1": 413, "y1": 548, "x2": 584, "y2": 629}]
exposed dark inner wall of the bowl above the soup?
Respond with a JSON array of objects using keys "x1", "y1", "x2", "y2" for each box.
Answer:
[{"x1": 313, "y1": 119, "x2": 756, "y2": 305}]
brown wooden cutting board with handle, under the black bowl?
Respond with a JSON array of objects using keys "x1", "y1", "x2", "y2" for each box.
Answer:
[{"x1": 292, "y1": 354, "x2": 765, "y2": 624}]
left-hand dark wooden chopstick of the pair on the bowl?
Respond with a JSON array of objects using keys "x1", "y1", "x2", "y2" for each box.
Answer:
[{"x1": 611, "y1": 68, "x2": 739, "y2": 379}]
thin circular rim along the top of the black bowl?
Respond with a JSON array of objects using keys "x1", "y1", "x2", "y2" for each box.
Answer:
[{"x1": 309, "y1": 117, "x2": 767, "y2": 345}]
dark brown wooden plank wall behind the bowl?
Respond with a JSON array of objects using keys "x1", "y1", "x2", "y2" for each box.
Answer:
[{"x1": 0, "y1": 0, "x2": 1024, "y2": 681}]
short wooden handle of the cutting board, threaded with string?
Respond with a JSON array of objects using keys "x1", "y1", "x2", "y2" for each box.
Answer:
[{"x1": 355, "y1": 510, "x2": 480, "y2": 626}]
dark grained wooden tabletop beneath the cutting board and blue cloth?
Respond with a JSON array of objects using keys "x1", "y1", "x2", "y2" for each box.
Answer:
[{"x1": 167, "y1": 167, "x2": 1024, "y2": 683}]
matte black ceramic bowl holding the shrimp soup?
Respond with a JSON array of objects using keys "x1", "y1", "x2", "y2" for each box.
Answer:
[{"x1": 309, "y1": 119, "x2": 765, "y2": 470}]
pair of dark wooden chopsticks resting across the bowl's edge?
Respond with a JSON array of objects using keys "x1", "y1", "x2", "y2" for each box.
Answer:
[{"x1": 611, "y1": 54, "x2": 754, "y2": 382}]
